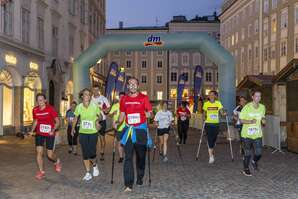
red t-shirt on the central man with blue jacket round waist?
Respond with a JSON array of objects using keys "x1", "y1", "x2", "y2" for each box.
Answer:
[{"x1": 120, "y1": 93, "x2": 152, "y2": 126}]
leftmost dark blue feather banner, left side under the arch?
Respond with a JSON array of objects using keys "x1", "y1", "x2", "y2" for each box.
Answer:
[{"x1": 105, "y1": 62, "x2": 118, "y2": 100}]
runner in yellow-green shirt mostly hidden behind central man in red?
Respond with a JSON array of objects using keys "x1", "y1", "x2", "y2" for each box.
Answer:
[{"x1": 110, "y1": 92, "x2": 125, "y2": 163}]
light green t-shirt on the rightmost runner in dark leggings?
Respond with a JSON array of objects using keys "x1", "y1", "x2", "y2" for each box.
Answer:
[{"x1": 239, "y1": 102, "x2": 266, "y2": 139}]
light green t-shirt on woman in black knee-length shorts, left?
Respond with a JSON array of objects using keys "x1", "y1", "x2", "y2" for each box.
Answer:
[{"x1": 74, "y1": 102, "x2": 101, "y2": 134}]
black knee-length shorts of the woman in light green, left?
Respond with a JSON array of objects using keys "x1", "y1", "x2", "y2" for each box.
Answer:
[{"x1": 79, "y1": 133, "x2": 98, "y2": 160}]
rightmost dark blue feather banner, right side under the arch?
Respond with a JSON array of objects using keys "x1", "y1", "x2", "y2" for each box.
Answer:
[{"x1": 193, "y1": 65, "x2": 204, "y2": 113}]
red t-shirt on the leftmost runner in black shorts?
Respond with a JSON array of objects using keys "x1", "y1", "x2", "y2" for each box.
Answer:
[{"x1": 33, "y1": 105, "x2": 58, "y2": 136}]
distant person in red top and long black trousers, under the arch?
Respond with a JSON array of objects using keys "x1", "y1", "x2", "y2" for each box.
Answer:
[{"x1": 176, "y1": 102, "x2": 190, "y2": 144}]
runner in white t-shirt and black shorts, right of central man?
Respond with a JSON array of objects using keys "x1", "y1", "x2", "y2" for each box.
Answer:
[{"x1": 154, "y1": 101, "x2": 174, "y2": 162}]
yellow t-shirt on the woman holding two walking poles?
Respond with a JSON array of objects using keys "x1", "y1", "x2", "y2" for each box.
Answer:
[{"x1": 203, "y1": 100, "x2": 223, "y2": 124}]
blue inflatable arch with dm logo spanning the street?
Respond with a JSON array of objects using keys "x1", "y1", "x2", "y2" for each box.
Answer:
[{"x1": 73, "y1": 32, "x2": 236, "y2": 114}]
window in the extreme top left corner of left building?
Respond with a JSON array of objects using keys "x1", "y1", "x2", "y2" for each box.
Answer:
[{"x1": 0, "y1": 2, "x2": 13, "y2": 35}]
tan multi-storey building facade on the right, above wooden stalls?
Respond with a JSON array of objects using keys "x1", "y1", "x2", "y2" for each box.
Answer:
[{"x1": 220, "y1": 0, "x2": 298, "y2": 121}]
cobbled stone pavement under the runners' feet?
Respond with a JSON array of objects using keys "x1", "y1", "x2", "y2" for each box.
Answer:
[{"x1": 0, "y1": 130, "x2": 298, "y2": 199}]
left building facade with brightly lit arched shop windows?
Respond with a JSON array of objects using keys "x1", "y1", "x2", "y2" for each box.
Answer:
[{"x1": 0, "y1": 0, "x2": 105, "y2": 135}]
